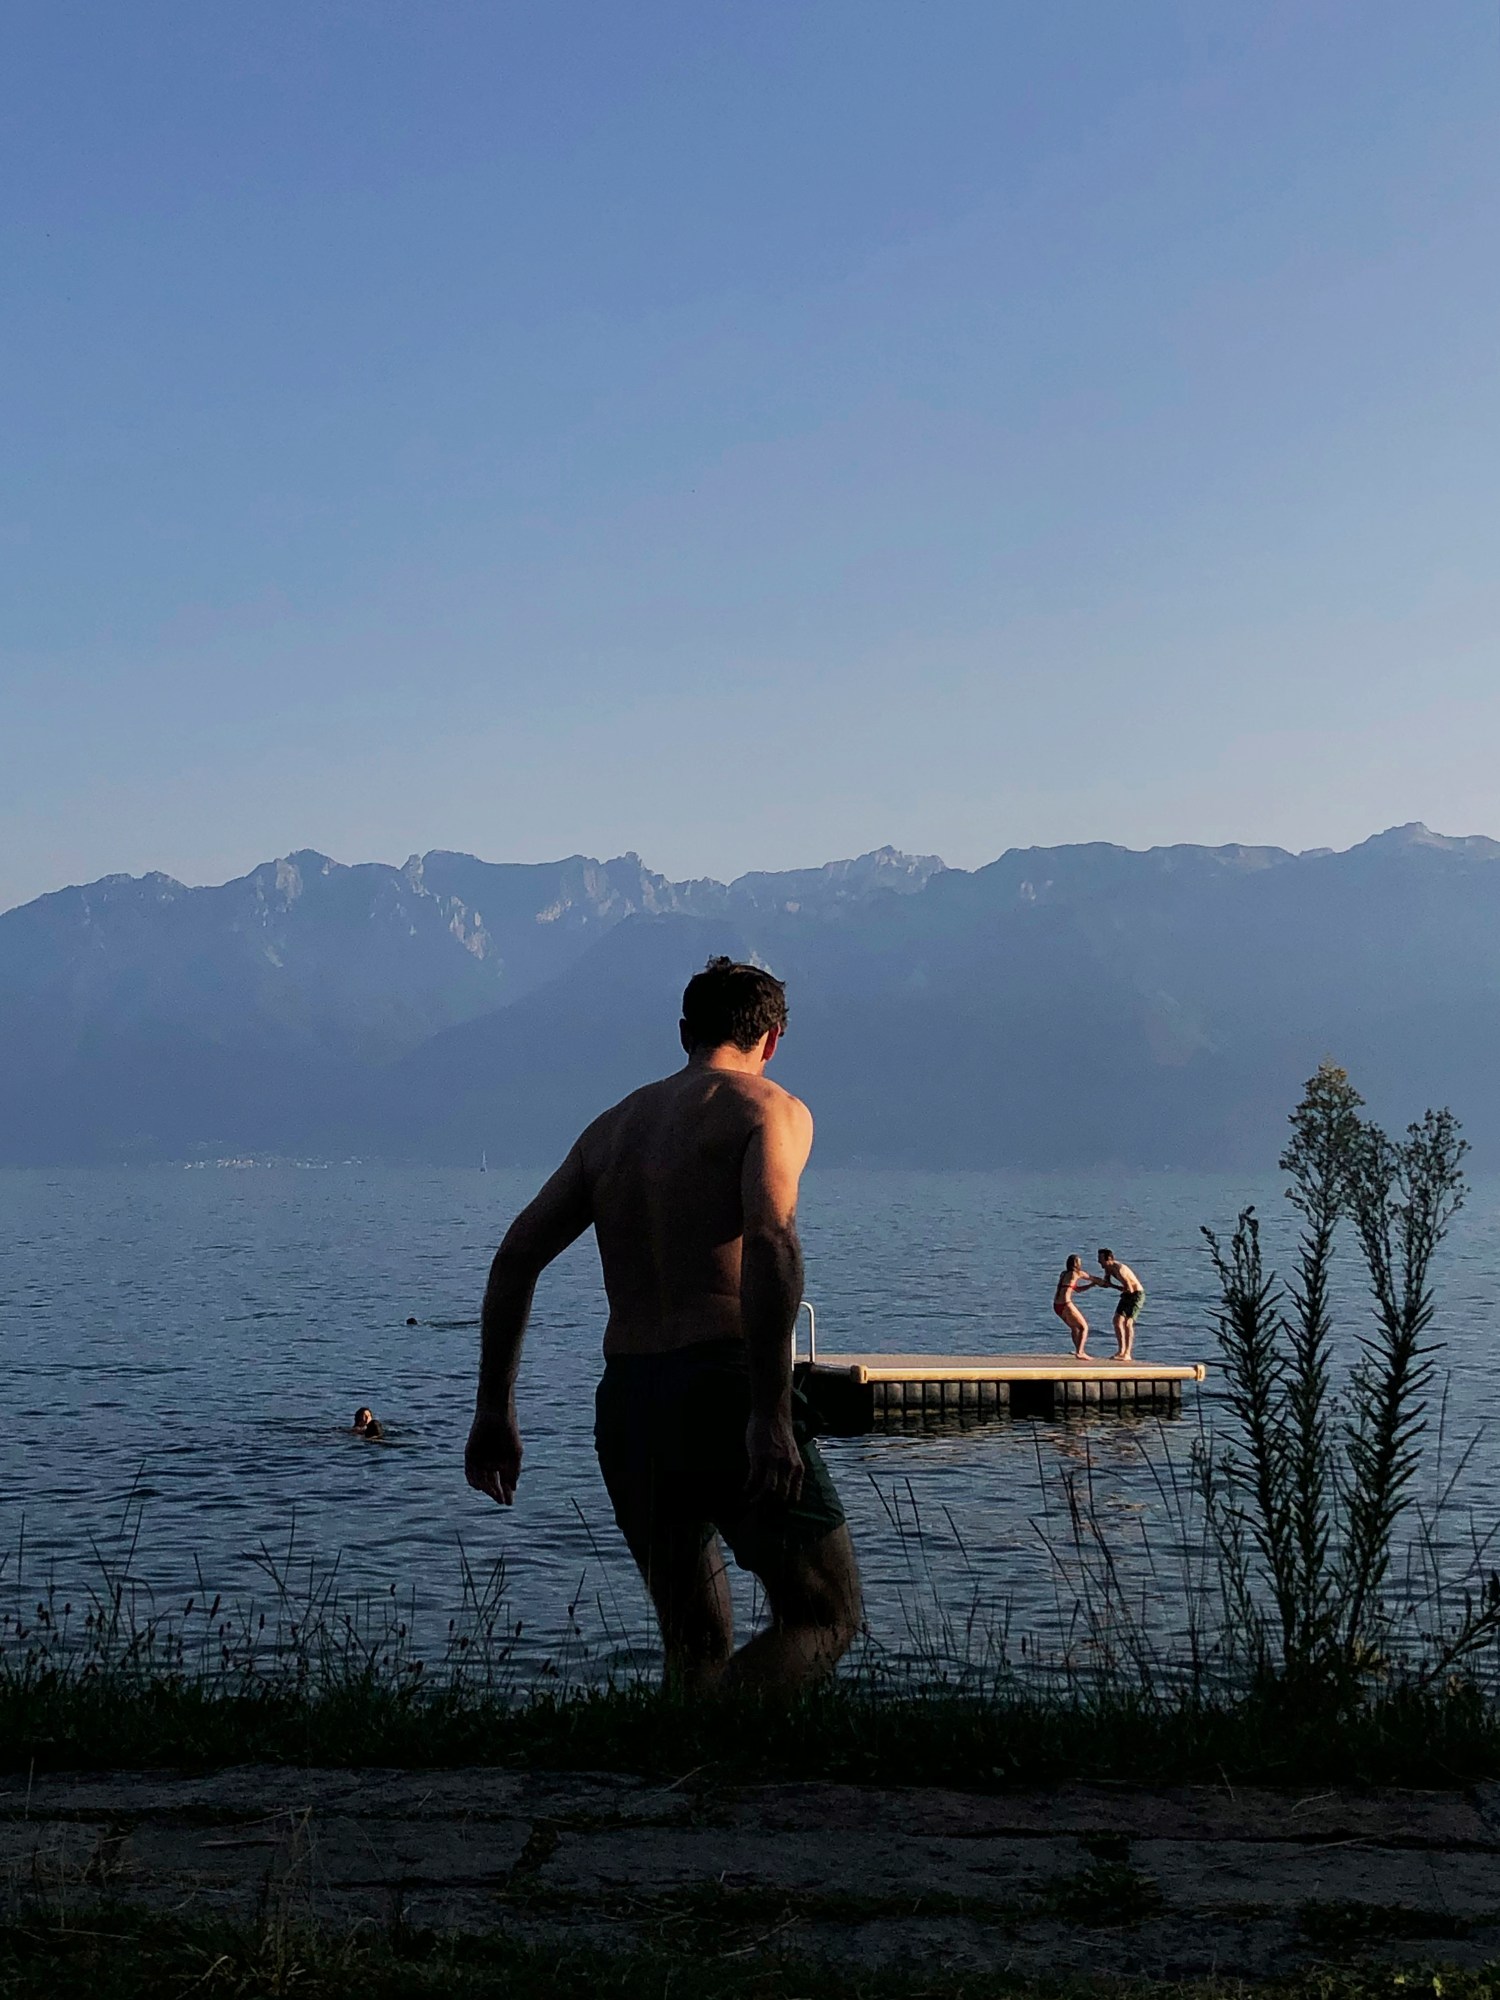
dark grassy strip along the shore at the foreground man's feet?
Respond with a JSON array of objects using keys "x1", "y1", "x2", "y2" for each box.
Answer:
[{"x1": 0, "y1": 1674, "x2": 1500, "y2": 1792}]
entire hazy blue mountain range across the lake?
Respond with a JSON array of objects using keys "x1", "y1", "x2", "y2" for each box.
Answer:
[{"x1": 0, "y1": 826, "x2": 1500, "y2": 1168}]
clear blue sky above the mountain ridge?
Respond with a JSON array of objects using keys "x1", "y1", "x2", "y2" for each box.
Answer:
[{"x1": 0, "y1": 0, "x2": 1500, "y2": 904}]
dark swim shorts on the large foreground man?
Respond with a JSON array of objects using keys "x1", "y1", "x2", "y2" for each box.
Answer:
[{"x1": 594, "y1": 1340, "x2": 844, "y2": 1576}]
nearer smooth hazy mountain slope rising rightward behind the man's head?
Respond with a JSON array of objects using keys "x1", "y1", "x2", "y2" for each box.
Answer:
[{"x1": 384, "y1": 828, "x2": 1500, "y2": 1168}]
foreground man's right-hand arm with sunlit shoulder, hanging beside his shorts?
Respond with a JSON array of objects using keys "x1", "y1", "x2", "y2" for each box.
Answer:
[{"x1": 740, "y1": 1096, "x2": 812, "y2": 1500}]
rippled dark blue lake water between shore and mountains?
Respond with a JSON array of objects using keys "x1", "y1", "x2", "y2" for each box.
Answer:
[{"x1": 0, "y1": 1164, "x2": 1500, "y2": 1672}]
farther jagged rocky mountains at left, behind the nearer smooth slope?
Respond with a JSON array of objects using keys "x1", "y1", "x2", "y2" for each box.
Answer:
[{"x1": 0, "y1": 848, "x2": 942, "y2": 1160}]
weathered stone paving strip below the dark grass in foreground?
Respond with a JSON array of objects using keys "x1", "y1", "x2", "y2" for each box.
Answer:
[{"x1": 0, "y1": 1768, "x2": 1500, "y2": 1980}]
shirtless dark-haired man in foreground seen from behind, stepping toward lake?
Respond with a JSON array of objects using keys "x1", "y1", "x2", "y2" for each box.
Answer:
[{"x1": 464, "y1": 958, "x2": 860, "y2": 1692}]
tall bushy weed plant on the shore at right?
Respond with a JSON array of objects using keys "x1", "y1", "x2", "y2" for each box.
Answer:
[{"x1": 1196, "y1": 1062, "x2": 1500, "y2": 1704}]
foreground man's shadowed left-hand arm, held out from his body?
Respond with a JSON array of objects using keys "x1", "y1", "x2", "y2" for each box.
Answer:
[{"x1": 464, "y1": 1146, "x2": 594, "y2": 1506}]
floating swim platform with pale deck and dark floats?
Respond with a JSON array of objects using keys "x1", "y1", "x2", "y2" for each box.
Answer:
[{"x1": 796, "y1": 1354, "x2": 1208, "y2": 1436}]
